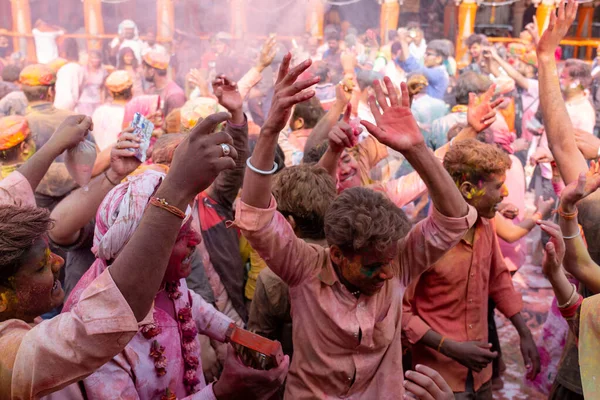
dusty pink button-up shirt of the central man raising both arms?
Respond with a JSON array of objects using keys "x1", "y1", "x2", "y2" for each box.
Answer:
[{"x1": 235, "y1": 198, "x2": 477, "y2": 400}]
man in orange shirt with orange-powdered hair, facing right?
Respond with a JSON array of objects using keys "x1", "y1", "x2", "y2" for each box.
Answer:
[{"x1": 402, "y1": 139, "x2": 540, "y2": 400}]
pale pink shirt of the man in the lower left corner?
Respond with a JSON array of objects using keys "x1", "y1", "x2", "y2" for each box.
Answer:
[{"x1": 0, "y1": 270, "x2": 148, "y2": 400}]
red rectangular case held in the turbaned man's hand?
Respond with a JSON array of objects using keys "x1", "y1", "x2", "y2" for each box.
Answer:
[{"x1": 226, "y1": 323, "x2": 284, "y2": 370}]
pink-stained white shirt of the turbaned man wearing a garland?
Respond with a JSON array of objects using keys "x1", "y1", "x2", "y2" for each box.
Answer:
[{"x1": 68, "y1": 279, "x2": 231, "y2": 400}]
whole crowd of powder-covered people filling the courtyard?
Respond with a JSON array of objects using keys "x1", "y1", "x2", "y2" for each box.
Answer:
[{"x1": 0, "y1": 0, "x2": 600, "y2": 400}]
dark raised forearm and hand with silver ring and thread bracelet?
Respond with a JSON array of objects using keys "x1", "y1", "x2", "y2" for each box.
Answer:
[{"x1": 109, "y1": 113, "x2": 237, "y2": 321}]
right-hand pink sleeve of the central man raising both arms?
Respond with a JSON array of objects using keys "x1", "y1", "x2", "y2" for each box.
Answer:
[{"x1": 399, "y1": 206, "x2": 477, "y2": 286}]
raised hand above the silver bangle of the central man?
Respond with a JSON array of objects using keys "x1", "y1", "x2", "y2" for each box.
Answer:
[{"x1": 261, "y1": 53, "x2": 319, "y2": 135}]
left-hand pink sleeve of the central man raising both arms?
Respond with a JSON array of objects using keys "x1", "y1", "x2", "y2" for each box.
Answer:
[{"x1": 235, "y1": 196, "x2": 326, "y2": 286}]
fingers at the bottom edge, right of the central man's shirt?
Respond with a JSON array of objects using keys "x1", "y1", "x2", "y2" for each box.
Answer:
[{"x1": 404, "y1": 365, "x2": 454, "y2": 400}]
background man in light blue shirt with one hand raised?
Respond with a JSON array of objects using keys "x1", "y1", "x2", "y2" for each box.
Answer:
[{"x1": 396, "y1": 31, "x2": 450, "y2": 99}]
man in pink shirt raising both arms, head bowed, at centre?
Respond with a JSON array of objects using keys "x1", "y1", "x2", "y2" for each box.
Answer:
[{"x1": 236, "y1": 54, "x2": 476, "y2": 399}]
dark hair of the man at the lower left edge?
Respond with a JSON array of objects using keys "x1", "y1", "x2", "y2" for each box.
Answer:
[{"x1": 0, "y1": 204, "x2": 52, "y2": 288}]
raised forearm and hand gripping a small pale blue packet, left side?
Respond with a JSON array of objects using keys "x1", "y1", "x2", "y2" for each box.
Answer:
[{"x1": 49, "y1": 128, "x2": 140, "y2": 246}]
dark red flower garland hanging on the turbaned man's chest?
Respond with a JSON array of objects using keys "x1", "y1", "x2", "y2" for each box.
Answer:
[{"x1": 141, "y1": 281, "x2": 200, "y2": 400}]
